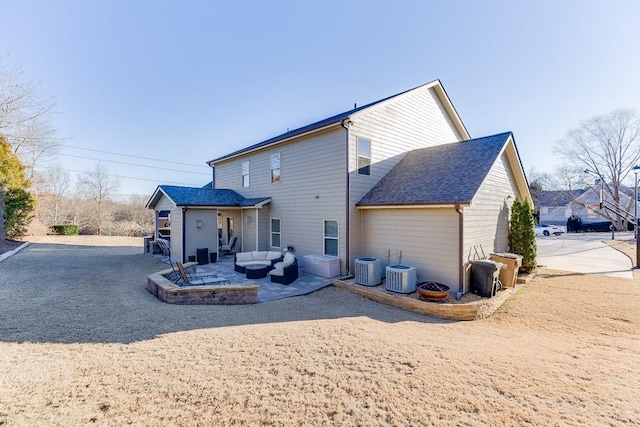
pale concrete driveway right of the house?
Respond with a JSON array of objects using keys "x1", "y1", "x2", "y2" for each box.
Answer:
[{"x1": 537, "y1": 233, "x2": 633, "y2": 279}]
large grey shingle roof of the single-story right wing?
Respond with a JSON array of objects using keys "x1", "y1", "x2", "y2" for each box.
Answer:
[{"x1": 357, "y1": 132, "x2": 512, "y2": 206}]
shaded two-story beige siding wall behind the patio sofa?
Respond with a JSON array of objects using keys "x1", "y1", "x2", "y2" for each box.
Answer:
[{"x1": 215, "y1": 125, "x2": 346, "y2": 274}]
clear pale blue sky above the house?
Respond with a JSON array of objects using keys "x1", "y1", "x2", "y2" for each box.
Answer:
[{"x1": 0, "y1": 0, "x2": 640, "y2": 194}]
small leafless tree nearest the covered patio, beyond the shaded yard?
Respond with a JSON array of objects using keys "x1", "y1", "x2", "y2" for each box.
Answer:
[{"x1": 80, "y1": 163, "x2": 120, "y2": 235}]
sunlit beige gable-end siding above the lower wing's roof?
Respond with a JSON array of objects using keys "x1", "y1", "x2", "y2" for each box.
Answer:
[{"x1": 349, "y1": 87, "x2": 461, "y2": 266}]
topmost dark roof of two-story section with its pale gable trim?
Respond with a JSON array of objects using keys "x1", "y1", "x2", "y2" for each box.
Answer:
[{"x1": 207, "y1": 80, "x2": 469, "y2": 166}]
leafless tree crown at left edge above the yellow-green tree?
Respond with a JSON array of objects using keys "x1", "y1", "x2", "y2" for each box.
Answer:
[{"x1": 0, "y1": 58, "x2": 60, "y2": 177}]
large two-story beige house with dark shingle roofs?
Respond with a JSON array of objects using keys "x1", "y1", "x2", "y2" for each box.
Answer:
[{"x1": 147, "y1": 80, "x2": 532, "y2": 300}]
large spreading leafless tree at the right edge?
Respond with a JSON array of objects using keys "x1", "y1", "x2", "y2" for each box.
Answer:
[{"x1": 556, "y1": 109, "x2": 640, "y2": 227}]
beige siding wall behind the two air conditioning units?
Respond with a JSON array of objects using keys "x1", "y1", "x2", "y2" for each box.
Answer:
[{"x1": 354, "y1": 208, "x2": 459, "y2": 290}]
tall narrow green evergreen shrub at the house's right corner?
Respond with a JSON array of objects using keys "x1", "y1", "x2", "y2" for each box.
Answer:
[{"x1": 509, "y1": 199, "x2": 538, "y2": 271}]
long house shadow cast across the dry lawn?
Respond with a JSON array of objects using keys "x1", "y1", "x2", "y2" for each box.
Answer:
[{"x1": 0, "y1": 243, "x2": 448, "y2": 343}]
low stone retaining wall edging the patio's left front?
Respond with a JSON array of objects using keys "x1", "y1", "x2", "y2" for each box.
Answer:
[{"x1": 147, "y1": 269, "x2": 260, "y2": 305}]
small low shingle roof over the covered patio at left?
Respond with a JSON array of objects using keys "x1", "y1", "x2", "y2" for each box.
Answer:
[{"x1": 159, "y1": 184, "x2": 269, "y2": 207}]
